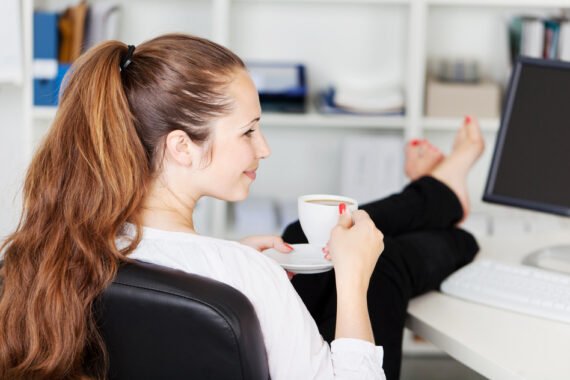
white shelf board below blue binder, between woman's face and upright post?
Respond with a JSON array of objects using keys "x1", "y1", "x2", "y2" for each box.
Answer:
[{"x1": 261, "y1": 112, "x2": 406, "y2": 129}]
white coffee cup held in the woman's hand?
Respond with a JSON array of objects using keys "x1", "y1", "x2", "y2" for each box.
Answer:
[{"x1": 297, "y1": 194, "x2": 358, "y2": 247}]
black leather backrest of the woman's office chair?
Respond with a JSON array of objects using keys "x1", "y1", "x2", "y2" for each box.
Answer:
[{"x1": 96, "y1": 261, "x2": 269, "y2": 380}]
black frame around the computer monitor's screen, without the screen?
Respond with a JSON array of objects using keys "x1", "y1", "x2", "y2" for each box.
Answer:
[{"x1": 483, "y1": 56, "x2": 570, "y2": 216}]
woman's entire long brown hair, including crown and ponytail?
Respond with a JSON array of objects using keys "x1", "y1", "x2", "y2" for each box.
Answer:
[{"x1": 0, "y1": 34, "x2": 244, "y2": 379}]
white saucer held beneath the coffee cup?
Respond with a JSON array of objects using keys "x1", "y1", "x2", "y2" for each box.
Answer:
[{"x1": 262, "y1": 244, "x2": 333, "y2": 274}]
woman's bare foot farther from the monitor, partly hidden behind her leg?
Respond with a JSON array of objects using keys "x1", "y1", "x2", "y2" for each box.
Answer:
[{"x1": 404, "y1": 140, "x2": 444, "y2": 181}]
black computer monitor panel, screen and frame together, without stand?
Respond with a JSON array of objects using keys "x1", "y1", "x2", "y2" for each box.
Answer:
[{"x1": 483, "y1": 57, "x2": 570, "y2": 215}]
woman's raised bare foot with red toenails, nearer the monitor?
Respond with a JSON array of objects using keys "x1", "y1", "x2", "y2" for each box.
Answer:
[{"x1": 431, "y1": 116, "x2": 485, "y2": 220}]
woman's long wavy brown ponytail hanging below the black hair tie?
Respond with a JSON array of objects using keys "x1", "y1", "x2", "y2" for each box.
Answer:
[{"x1": 0, "y1": 42, "x2": 149, "y2": 379}]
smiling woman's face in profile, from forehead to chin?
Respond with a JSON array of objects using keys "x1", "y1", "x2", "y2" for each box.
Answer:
[{"x1": 195, "y1": 70, "x2": 271, "y2": 201}]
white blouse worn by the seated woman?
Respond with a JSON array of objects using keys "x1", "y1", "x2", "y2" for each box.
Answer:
[{"x1": 122, "y1": 227, "x2": 385, "y2": 380}]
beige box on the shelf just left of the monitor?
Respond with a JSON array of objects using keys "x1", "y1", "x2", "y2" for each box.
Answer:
[{"x1": 426, "y1": 80, "x2": 501, "y2": 118}]
